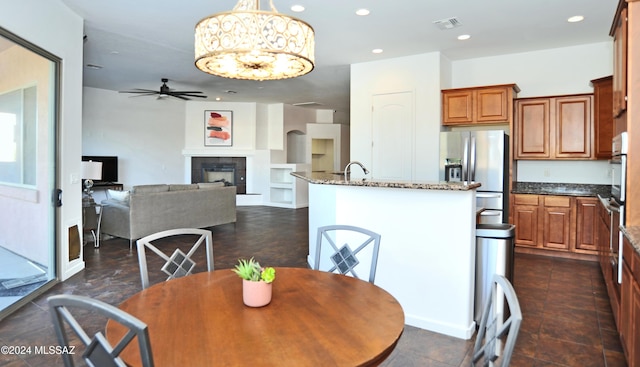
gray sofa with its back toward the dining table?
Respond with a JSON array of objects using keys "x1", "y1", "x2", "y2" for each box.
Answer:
[{"x1": 100, "y1": 183, "x2": 236, "y2": 245}]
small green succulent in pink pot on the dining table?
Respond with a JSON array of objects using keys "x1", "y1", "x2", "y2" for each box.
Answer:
[{"x1": 232, "y1": 257, "x2": 276, "y2": 307}]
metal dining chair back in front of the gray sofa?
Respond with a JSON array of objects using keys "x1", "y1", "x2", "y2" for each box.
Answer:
[{"x1": 137, "y1": 228, "x2": 213, "y2": 289}]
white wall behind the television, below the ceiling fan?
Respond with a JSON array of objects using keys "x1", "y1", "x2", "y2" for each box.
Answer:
[{"x1": 82, "y1": 87, "x2": 188, "y2": 189}]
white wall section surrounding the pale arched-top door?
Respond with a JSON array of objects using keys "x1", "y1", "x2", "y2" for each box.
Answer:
[{"x1": 350, "y1": 52, "x2": 446, "y2": 181}]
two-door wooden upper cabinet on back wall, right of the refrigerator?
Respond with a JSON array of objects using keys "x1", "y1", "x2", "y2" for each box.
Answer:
[{"x1": 514, "y1": 94, "x2": 594, "y2": 159}]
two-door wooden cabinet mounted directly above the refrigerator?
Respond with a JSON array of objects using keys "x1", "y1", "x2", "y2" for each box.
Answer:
[{"x1": 442, "y1": 84, "x2": 520, "y2": 125}]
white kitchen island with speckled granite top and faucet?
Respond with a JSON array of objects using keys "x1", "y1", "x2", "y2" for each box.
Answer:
[{"x1": 292, "y1": 172, "x2": 480, "y2": 339}]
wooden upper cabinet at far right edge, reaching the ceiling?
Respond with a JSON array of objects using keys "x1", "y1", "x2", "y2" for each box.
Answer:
[{"x1": 610, "y1": 5, "x2": 628, "y2": 117}]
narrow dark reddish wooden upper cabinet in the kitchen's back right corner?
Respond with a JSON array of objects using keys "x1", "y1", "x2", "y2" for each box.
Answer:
[{"x1": 591, "y1": 76, "x2": 614, "y2": 159}]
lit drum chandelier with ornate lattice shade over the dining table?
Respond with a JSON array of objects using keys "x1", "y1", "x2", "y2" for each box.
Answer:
[{"x1": 195, "y1": 0, "x2": 315, "y2": 80}]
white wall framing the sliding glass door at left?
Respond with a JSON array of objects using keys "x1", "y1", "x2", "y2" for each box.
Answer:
[{"x1": 0, "y1": 0, "x2": 84, "y2": 280}]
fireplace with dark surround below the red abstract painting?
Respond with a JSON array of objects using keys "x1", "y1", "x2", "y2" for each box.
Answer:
[{"x1": 191, "y1": 157, "x2": 247, "y2": 194}]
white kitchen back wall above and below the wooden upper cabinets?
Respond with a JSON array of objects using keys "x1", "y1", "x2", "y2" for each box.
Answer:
[{"x1": 451, "y1": 42, "x2": 613, "y2": 185}]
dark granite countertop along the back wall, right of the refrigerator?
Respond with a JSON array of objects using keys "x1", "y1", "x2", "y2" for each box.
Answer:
[{"x1": 511, "y1": 182, "x2": 611, "y2": 198}]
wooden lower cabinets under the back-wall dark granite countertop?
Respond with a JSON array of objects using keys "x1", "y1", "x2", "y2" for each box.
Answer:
[{"x1": 512, "y1": 194, "x2": 598, "y2": 256}]
